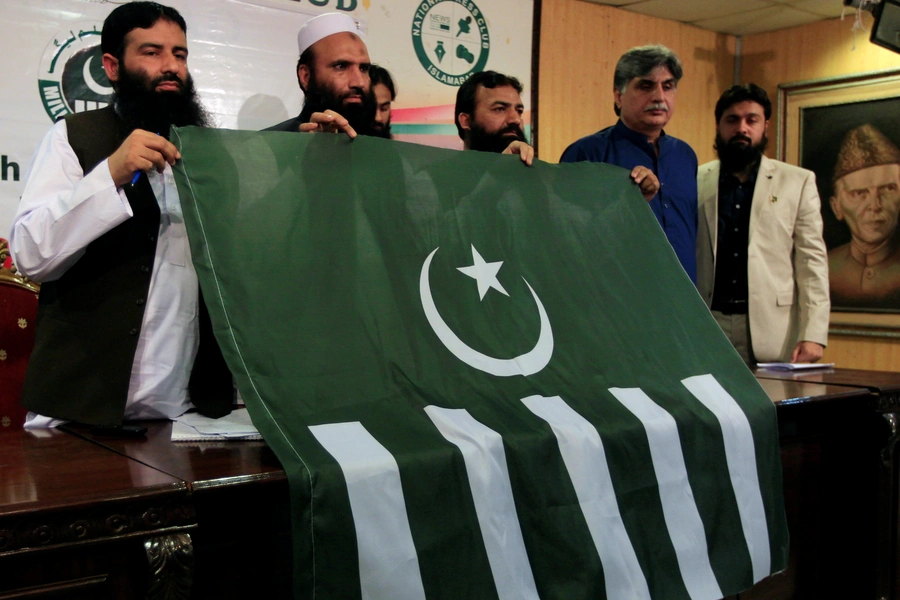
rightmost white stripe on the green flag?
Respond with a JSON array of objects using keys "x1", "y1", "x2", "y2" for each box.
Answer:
[{"x1": 681, "y1": 375, "x2": 772, "y2": 583}]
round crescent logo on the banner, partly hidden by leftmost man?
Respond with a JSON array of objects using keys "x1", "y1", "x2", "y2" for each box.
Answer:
[{"x1": 38, "y1": 23, "x2": 113, "y2": 121}]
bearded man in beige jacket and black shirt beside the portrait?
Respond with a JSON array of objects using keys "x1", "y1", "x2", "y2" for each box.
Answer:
[{"x1": 697, "y1": 83, "x2": 831, "y2": 364}]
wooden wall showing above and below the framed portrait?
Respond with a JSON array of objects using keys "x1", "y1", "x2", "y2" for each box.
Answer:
[{"x1": 740, "y1": 13, "x2": 900, "y2": 371}]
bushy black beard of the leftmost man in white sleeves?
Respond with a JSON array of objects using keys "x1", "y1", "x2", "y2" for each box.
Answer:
[{"x1": 113, "y1": 60, "x2": 213, "y2": 138}]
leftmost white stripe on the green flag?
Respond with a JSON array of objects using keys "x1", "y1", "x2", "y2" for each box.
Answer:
[{"x1": 309, "y1": 422, "x2": 425, "y2": 600}]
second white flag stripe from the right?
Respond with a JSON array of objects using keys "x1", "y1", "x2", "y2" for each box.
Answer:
[{"x1": 609, "y1": 388, "x2": 722, "y2": 600}]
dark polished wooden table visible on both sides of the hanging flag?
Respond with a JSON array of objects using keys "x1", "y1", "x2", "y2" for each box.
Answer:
[{"x1": 0, "y1": 371, "x2": 900, "y2": 600}]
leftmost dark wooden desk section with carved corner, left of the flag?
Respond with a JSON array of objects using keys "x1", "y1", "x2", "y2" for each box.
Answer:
[{"x1": 0, "y1": 431, "x2": 195, "y2": 599}]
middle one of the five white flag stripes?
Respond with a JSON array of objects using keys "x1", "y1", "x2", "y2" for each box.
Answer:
[{"x1": 522, "y1": 396, "x2": 650, "y2": 600}]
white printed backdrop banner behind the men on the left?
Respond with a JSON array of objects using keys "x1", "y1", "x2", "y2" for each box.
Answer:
[{"x1": 0, "y1": 0, "x2": 534, "y2": 238}]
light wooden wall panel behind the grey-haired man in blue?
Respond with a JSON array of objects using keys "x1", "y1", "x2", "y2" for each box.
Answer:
[{"x1": 538, "y1": 0, "x2": 735, "y2": 164}]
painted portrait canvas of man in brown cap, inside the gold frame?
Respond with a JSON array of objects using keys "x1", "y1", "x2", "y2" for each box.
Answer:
[{"x1": 799, "y1": 98, "x2": 900, "y2": 312}]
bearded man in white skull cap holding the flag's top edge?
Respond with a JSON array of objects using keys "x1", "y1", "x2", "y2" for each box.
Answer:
[{"x1": 269, "y1": 12, "x2": 375, "y2": 138}]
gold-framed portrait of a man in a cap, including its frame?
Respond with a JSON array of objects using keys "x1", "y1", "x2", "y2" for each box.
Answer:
[{"x1": 777, "y1": 69, "x2": 900, "y2": 313}]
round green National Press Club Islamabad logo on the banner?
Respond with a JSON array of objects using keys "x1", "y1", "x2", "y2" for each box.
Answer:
[{"x1": 412, "y1": 0, "x2": 491, "y2": 86}]
